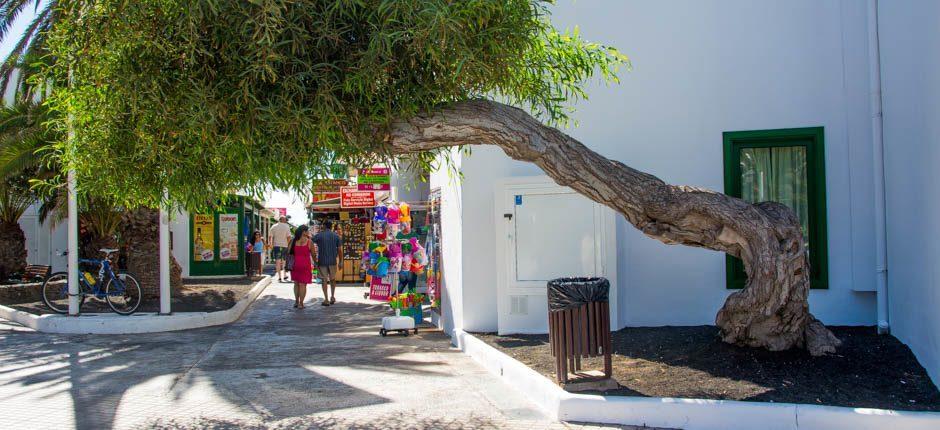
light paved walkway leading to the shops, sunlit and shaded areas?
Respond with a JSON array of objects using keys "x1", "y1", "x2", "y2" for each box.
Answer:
[{"x1": 0, "y1": 282, "x2": 648, "y2": 429}]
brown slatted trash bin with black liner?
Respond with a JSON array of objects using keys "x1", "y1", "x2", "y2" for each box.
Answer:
[{"x1": 548, "y1": 278, "x2": 611, "y2": 385}]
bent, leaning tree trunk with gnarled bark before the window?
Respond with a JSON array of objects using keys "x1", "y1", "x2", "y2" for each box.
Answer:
[{"x1": 384, "y1": 100, "x2": 840, "y2": 355}]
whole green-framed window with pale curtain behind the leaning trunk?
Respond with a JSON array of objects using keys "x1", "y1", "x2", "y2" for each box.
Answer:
[{"x1": 724, "y1": 127, "x2": 829, "y2": 288}]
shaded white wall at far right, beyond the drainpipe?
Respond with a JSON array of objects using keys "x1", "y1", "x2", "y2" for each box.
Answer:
[{"x1": 879, "y1": 0, "x2": 940, "y2": 382}]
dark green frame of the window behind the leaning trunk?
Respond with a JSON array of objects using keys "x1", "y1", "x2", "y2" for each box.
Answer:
[{"x1": 723, "y1": 127, "x2": 829, "y2": 289}]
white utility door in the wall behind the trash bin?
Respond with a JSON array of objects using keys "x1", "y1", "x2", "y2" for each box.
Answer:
[{"x1": 496, "y1": 177, "x2": 617, "y2": 334}]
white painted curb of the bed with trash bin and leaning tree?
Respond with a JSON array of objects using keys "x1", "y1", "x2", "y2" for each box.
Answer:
[{"x1": 453, "y1": 330, "x2": 940, "y2": 430}]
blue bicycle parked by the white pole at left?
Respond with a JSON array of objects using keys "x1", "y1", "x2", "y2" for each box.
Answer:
[{"x1": 42, "y1": 248, "x2": 143, "y2": 315}]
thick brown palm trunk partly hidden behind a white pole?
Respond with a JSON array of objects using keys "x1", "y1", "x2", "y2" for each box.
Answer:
[{"x1": 121, "y1": 208, "x2": 183, "y2": 297}]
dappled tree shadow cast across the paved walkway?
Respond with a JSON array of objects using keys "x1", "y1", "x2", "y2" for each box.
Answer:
[{"x1": 0, "y1": 288, "x2": 458, "y2": 429}]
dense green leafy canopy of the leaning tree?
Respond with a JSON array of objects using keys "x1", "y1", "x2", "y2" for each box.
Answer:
[{"x1": 42, "y1": 0, "x2": 626, "y2": 207}]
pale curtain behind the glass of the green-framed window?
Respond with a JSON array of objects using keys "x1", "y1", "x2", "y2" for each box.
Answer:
[{"x1": 741, "y1": 146, "x2": 809, "y2": 250}]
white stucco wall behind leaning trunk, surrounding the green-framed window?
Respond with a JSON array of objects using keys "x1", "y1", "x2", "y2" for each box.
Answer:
[{"x1": 436, "y1": 0, "x2": 875, "y2": 331}]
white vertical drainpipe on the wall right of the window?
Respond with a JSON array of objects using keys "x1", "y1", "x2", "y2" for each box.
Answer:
[{"x1": 868, "y1": 0, "x2": 891, "y2": 334}]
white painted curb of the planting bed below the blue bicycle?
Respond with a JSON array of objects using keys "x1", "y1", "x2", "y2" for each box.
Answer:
[{"x1": 0, "y1": 276, "x2": 271, "y2": 334}]
